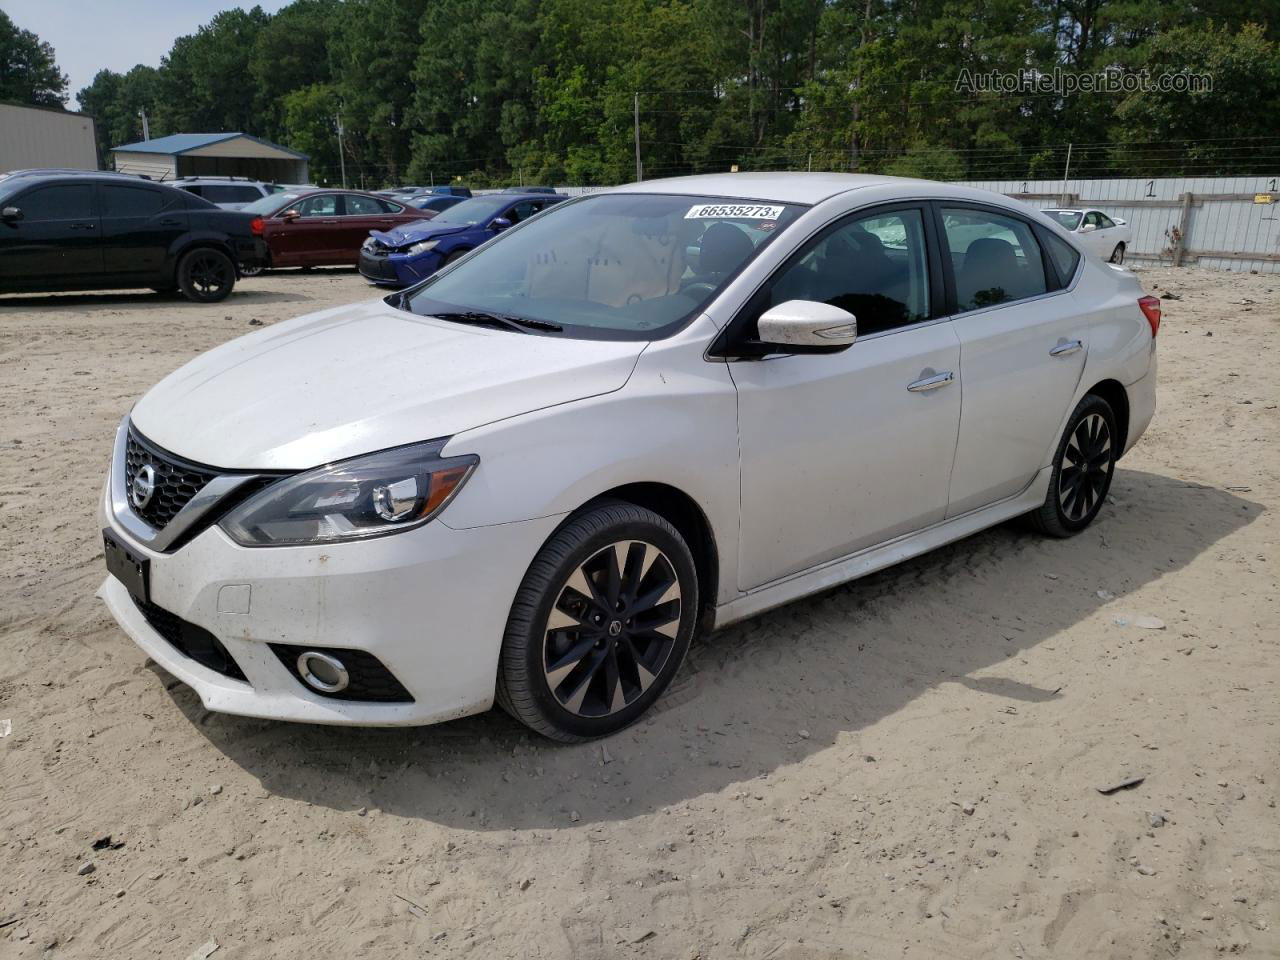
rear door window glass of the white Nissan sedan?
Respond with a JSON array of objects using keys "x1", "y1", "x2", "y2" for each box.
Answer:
[{"x1": 942, "y1": 207, "x2": 1048, "y2": 312}]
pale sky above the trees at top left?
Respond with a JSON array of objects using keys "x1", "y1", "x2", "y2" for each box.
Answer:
[{"x1": 0, "y1": 0, "x2": 288, "y2": 110}]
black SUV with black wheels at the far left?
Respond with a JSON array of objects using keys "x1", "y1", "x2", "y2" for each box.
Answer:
[{"x1": 0, "y1": 170, "x2": 266, "y2": 303}]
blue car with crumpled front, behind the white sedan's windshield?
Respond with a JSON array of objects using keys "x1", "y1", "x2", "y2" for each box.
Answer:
[{"x1": 360, "y1": 193, "x2": 568, "y2": 287}]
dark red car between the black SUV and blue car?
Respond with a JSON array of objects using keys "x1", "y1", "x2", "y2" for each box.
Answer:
[{"x1": 241, "y1": 189, "x2": 434, "y2": 266}]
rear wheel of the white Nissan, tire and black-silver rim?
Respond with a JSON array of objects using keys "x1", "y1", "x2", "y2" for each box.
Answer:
[{"x1": 1028, "y1": 393, "x2": 1123, "y2": 538}]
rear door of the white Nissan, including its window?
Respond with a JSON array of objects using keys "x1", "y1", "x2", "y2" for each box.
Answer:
[{"x1": 940, "y1": 206, "x2": 1088, "y2": 516}]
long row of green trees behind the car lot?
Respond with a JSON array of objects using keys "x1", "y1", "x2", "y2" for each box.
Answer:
[{"x1": 64, "y1": 0, "x2": 1280, "y2": 187}]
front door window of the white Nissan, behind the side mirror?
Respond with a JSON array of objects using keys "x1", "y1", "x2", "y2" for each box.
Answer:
[{"x1": 762, "y1": 210, "x2": 929, "y2": 337}]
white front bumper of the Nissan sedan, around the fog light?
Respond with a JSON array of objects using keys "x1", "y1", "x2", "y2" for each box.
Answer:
[{"x1": 99, "y1": 478, "x2": 557, "y2": 726}]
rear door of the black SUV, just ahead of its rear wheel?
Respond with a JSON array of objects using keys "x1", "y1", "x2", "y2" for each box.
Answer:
[{"x1": 97, "y1": 183, "x2": 187, "y2": 280}]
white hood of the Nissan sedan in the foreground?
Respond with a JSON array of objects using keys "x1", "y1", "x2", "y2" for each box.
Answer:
[{"x1": 132, "y1": 301, "x2": 645, "y2": 470}]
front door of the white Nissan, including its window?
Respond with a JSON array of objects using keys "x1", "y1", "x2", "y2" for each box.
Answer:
[{"x1": 730, "y1": 206, "x2": 960, "y2": 590}]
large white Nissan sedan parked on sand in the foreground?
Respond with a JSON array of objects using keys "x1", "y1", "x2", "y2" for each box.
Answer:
[{"x1": 101, "y1": 174, "x2": 1160, "y2": 740}]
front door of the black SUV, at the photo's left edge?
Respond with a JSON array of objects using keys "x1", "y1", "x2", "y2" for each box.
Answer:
[{"x1": 0, "y1": 182, "x2": 102, "y2": 287}]
